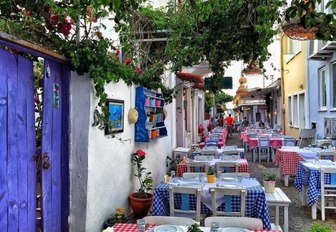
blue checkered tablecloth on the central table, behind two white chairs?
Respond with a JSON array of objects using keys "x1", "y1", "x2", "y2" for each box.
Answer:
[{"x1": 152, "y1": 182, "x2": 271, "y2": 230}]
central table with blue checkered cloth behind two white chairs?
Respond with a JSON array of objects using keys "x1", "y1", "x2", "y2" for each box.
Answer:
[{"x1": 152, "y1": 178, "x2": 271, "y2": 229}]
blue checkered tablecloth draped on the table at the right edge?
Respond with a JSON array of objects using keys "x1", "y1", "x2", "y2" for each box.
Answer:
[{"x1": 294, "y1": 161, "x2": 331, "y2": 206}]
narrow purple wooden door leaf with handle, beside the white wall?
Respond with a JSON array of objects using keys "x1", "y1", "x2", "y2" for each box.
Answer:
[{"x1": 41, "y1": 59, "x2": 70, "y2": 232}]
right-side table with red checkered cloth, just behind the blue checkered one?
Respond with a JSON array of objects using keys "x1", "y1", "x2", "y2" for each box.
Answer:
[{"x1": 273, "y1": 147, "x2": 317, "y2": 186}]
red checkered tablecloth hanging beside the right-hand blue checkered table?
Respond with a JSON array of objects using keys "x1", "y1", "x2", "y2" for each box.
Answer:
[{"x1": 273, "y1": 149, "x2": 304, "y2": 175}]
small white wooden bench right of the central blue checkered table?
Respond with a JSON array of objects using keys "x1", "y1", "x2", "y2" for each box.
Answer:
[{"x1": 265, "y1": 188, "x2": 291, "y2": 232}]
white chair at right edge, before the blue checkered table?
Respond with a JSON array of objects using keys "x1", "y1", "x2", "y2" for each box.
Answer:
[{"x1": 317, "y1": 168, "x2": 336, "y2": 221}]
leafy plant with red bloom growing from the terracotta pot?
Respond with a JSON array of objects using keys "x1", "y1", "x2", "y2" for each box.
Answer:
[{"x1": 131, "y1": 150, "x2": 153, "y2": 198}]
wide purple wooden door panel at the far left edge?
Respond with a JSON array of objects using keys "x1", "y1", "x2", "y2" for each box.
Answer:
[{"x1": 0, "y1": 49, "x2": 36, "y2": 231}]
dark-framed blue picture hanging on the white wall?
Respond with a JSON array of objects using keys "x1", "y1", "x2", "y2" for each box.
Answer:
[{"x1": 105, "y1": 99, "x2": 124, "y2": 134}]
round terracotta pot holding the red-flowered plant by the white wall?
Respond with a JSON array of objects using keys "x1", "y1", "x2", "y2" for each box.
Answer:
[{"x1": 128, "y1": 193, "x2": 153, "y2": 219}]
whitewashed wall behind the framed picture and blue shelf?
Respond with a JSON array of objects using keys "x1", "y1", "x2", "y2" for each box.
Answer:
[{"x1": 70, "y1": 72, "x2": 175, "y2": 232}]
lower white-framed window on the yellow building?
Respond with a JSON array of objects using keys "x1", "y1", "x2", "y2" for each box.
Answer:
[{"x1": 288, "y1": 92, "x2": 306, "y2": 128}]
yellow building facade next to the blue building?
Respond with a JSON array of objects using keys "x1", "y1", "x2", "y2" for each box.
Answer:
[{"x1": 281, "y1": 35, "x2": 307, "y2": 138}]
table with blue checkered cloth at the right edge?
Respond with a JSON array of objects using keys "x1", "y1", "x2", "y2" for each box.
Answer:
[{"x1": 294, "y1": 160, "x2": 336, "y2": 219}]
